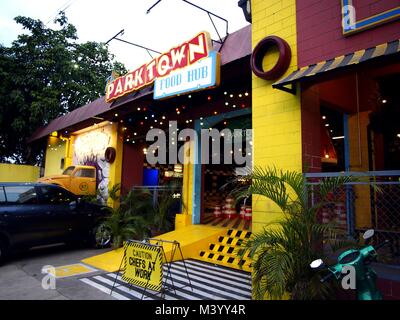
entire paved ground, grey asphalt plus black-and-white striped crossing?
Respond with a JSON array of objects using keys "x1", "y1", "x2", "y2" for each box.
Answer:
[{"x1": 0, "y1": 246, "x2": 251, "y2": 300}]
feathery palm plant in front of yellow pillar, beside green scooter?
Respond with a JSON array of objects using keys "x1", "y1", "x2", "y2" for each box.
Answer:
[{"x1": 236, "y1": 168, "x2": 354, "y2": 300}]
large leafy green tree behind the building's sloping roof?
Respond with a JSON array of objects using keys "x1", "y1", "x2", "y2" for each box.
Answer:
[{"x1": 0, "y1": 12, "x2": 126, "y2": 164}]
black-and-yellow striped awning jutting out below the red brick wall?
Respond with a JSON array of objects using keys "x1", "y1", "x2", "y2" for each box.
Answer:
[{"x1": 272, "y1": 40, "x2": 400, "y2": 91}]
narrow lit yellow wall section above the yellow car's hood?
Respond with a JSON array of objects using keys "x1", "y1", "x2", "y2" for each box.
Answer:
[{"x1": 44, "y1": 136, "x2": 66, "y2": 176}]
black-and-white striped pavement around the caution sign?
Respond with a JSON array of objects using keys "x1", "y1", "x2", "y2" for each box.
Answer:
[{"x1": 80, "y1": 259, "x2": 251, "y2": 300}]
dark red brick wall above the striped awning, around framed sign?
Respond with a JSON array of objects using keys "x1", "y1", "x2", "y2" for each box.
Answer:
[{"x1": 296, "y1": 0, "x2": 400, "y2": 67}]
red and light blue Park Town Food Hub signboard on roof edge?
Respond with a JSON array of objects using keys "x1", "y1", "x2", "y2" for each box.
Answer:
[{"x1": 106, "y1": 32, "x2": 220, "y2": 102}]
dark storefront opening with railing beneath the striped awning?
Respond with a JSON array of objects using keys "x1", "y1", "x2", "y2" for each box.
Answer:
[{"x1": 302, "y1": 59, "x2": 400, "y2": 263}]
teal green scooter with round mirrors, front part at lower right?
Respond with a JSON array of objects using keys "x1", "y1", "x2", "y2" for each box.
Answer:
[{"x1": 310, "y1": 229, "x2": 389, "y2": 300}]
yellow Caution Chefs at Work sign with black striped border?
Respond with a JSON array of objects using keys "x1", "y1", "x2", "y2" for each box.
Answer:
[{"x1": 122, "y1": 241, "x2": 163, "y2": 292}]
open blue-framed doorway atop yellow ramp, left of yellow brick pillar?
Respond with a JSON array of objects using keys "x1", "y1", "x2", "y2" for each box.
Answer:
[{"x1": 200, "y1": 110, "x2": 252, "y2": 230}]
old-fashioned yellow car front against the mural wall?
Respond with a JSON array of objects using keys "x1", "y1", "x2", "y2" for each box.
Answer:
[{"x1": 37, "y1": 165, "x2": 96, "y2": 195}]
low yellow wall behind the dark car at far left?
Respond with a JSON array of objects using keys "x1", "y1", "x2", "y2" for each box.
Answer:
[{"x1": 0, "y1": 163, "x2": 40, "y2": 182}]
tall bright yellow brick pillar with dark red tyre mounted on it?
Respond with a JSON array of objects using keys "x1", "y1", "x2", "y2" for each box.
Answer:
[{"x1": 251, "y1": 0, "x2": 302, "y2": 232}]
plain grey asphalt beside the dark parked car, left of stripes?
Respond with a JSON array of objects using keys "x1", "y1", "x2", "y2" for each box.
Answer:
[{"x1": 0, "y1": 246, "x2": 114, "y2": 300}]
